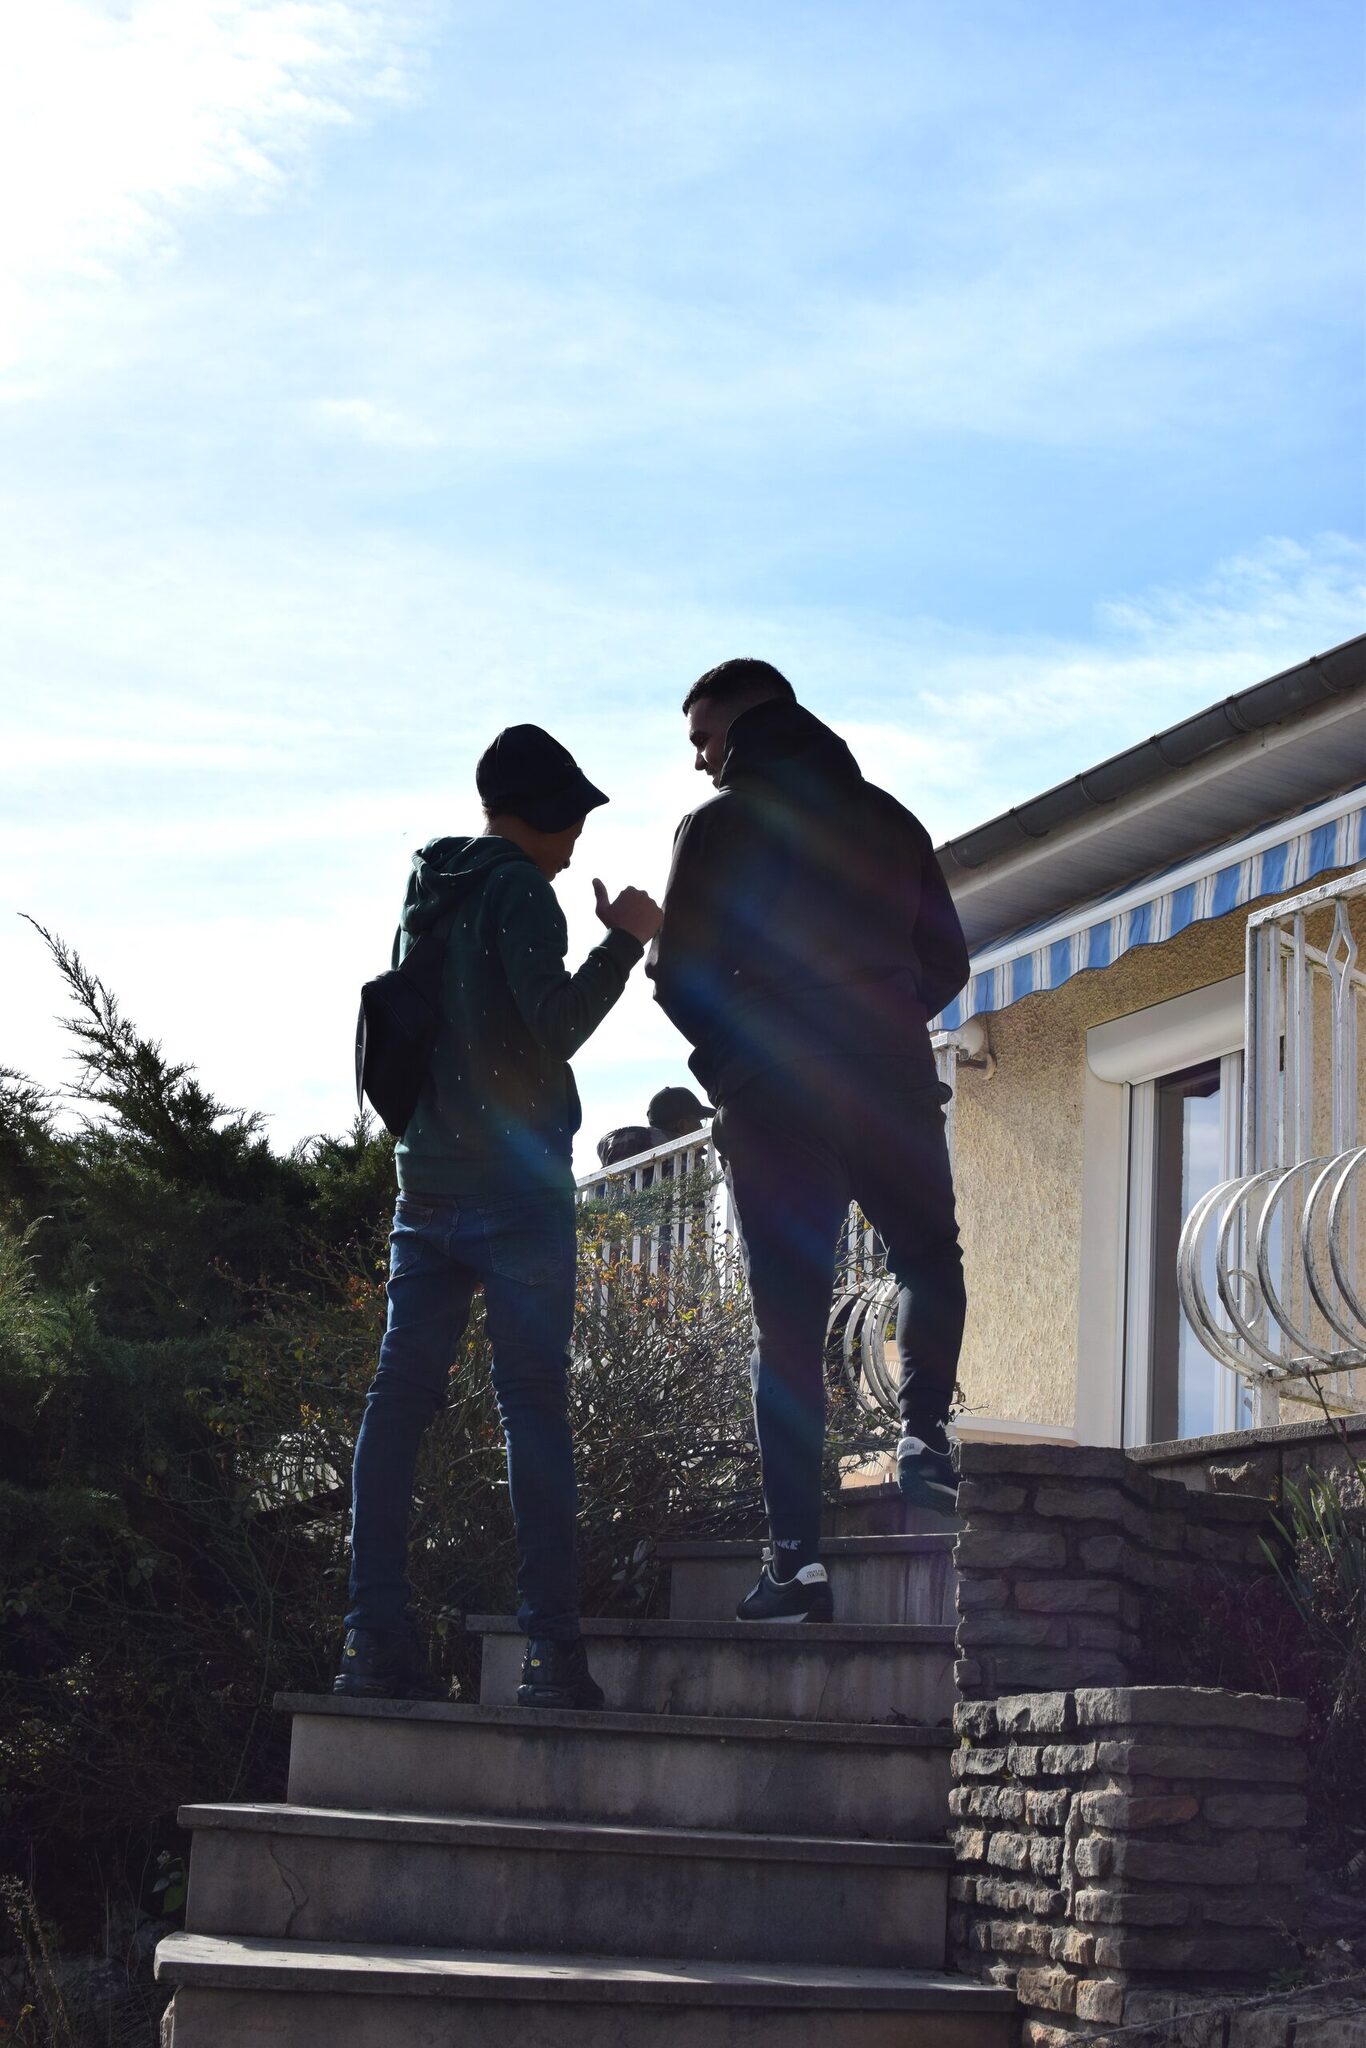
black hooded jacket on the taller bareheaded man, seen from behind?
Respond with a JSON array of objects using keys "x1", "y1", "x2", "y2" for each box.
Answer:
[{"x1": 647, "y1": 702, "x2": 969, "y2": 1102}]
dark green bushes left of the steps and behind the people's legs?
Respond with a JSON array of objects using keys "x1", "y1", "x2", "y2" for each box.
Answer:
[{"x1": 0, "y1": 940, "x2": 877, "y2": 1974}]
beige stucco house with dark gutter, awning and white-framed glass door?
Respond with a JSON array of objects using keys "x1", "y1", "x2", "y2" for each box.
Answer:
[{"x1": 938, "y1": 635, "x2": 1366, "y2": 1446}]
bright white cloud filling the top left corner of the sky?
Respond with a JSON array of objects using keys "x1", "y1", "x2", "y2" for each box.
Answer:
[{"x1": 0, "y1": 0, "x2": 426, "y2": 389}]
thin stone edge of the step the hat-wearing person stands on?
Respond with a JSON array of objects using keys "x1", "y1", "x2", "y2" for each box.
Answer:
[{"x1": 274, "y1": 1692, "x2": 954, "y2": 1749}]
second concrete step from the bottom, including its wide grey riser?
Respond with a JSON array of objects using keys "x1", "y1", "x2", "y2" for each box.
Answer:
[{"x1": 180, "y1": 1804, "x2": 952, "y2": 1968}]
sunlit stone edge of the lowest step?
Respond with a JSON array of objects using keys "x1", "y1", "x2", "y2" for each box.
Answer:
[{"x1": 156, "y1": 1931, "x2": 1016, "y2": 2013}]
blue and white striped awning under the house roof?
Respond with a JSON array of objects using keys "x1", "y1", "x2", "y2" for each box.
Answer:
[{"x1": 934, "y1": 784, "x2": 1366, "y2": 1030}]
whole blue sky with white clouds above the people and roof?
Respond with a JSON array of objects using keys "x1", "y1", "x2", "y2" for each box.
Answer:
[{"x1": 0, "y1": 0, "x2": 1366, "y2": 1167}]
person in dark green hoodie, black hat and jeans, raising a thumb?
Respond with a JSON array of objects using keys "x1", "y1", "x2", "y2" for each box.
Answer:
[{"x1": 334, "y1": 725, "x2": 659, "y2": 1708}]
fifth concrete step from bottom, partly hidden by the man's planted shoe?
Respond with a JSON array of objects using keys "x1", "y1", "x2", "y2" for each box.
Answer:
[{"x1": 659, "y1": 1530, "x2": 956, "y2": 1626}]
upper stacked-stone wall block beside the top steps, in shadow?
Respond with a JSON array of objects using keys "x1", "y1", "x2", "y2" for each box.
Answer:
[{"x1": 954, "y1": 1444, "x2": 1272, "y2": 1700}]
